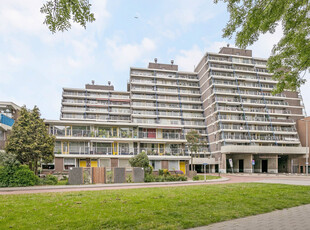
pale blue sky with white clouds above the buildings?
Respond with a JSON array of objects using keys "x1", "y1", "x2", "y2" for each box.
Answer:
[{"x1": 0, "y1": 0, "x2": 310, "y2": 119}]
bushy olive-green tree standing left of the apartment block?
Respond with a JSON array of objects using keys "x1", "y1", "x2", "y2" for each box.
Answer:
[{"x1": 5, "y1": 106, "x2": 55, "y2": 174}]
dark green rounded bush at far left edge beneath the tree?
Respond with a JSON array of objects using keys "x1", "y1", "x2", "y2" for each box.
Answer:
[{"x1": 0, "y1": 165, "x2": 39, "y2": 187}]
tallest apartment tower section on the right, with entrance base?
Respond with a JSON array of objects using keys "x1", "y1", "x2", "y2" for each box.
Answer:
[{"x1": 195, "y1": 47, "x2": 305, "y2": 173}]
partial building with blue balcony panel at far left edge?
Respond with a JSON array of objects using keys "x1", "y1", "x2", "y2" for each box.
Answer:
[{"x1": 0, "y1": 101, "x2": 21, "y2": 151}]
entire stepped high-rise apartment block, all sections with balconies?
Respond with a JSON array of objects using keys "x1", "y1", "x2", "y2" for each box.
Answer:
[{"x1": 43, "y1": 47, "x2": 305, "y2": 173}]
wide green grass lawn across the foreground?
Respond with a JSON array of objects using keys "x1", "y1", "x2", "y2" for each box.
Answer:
[{"x1": 0, "y1": 183, "x2": 310, "y2": 229}]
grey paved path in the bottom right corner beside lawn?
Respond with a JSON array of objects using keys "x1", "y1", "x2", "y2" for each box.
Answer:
[{"x1": 193, "y1": 204, "x2": 310, "y2": 230}]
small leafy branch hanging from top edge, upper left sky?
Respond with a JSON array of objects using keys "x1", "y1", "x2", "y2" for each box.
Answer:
[{"x1": 40, "y1": 0, "x2": 95, "y2": 33}]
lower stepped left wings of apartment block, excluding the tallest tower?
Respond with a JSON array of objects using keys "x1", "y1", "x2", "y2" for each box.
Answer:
[{"x1": 43, "y1": 60, "x2": 211, "y2": 173}]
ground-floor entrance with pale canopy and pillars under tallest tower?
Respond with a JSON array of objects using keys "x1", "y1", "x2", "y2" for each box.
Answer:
[{"x1": 219, "y1": 146, "x2": 309, "y2": 173}]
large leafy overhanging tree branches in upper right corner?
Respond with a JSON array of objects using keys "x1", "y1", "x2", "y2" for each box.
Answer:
[{"x1": 215, "y1": 0, "x2": 310, "y2": 93}]
